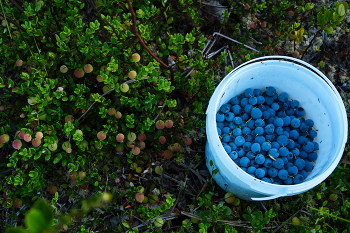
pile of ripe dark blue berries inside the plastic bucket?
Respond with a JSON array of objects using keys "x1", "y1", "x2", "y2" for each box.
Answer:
[{"x1": 216, "y1": 87, "x2": 319, "y2": 185}]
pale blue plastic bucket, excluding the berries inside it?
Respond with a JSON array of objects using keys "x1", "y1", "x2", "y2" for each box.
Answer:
[{"x1": 205, "y1": 56, "x2": 348, "y2": 201}]
